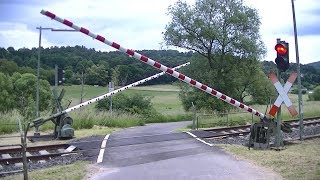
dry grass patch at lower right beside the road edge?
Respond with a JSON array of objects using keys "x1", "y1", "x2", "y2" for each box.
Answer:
[{"x1": 219, "y1": 138, "x2": 320, "y2": 180}]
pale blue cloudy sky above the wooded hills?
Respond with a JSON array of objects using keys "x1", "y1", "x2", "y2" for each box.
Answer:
[{"x1": 0, "y1": 0, "x2": 320, "y2": 64}]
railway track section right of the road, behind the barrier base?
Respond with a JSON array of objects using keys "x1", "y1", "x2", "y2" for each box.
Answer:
[{"x1": 192, "y1": 117, "x2": 320, "y2": 139}]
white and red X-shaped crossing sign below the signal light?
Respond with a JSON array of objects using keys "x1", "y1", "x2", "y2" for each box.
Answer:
[{"x1": 269, "y1": 72, "x2": 298, "y2": 116}]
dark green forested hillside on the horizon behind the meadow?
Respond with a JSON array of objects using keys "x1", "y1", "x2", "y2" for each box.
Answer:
[{"x1": 0, "y1": 46, "x2": 320, "y2": 89}]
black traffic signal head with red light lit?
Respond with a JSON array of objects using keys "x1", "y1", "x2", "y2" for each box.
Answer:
[{"x1": 274, "y1": 41, "x2": 289, "y2": 72}]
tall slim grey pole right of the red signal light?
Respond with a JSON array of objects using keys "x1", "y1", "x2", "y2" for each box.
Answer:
[{"x1": 291, "y1": 0, "x2": 304, "y2": 140}]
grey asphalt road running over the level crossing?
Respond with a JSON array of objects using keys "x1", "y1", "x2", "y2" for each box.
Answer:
[{"x1": 87, "y1": 122, "x2": 279, "y2": 180}]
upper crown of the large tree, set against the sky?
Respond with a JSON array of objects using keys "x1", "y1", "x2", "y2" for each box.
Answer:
[{"x1": 164, "y1": 0, "x2": 264, "y2": 64}]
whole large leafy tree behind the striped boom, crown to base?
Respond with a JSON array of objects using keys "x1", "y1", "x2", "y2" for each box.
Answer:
[{"x1": 164, "y1": 0, "x2": 264, "y2": 111}]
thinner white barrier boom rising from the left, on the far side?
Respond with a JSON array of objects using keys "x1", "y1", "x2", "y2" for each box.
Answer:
[{"x1": 30, "y1": 62, "x2": 190, "y2": 127}]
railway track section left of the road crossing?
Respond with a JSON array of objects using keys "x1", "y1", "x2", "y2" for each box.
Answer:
[{"x1": 0, "y1": 144, "x2": 77, "y2": 176}]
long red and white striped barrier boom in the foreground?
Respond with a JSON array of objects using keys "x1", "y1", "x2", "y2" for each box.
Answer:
[{"x1": 41, "y1": 10, "x2": 265, "y2": 119}]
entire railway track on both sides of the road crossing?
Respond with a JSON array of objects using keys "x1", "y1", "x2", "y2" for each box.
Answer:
[{"x1": 0, "y1": 117, "x2": 320, "y2": 177}]
